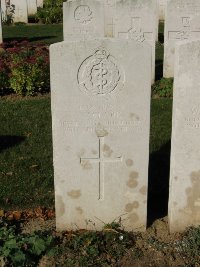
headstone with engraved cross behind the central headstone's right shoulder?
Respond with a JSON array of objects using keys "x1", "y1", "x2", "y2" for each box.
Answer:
[{"x1": 115, "y1": 0, "x2": 158, "y2": 82}]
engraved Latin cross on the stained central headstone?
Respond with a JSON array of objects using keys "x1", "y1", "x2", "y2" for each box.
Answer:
[{"x1": 80, "y1": 137, "x2": 122, "y2": 200}]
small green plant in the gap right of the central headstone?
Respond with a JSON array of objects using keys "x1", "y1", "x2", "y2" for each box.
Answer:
[{"x1": 152, "y1": 78, "x2": 173, "y2": 97}]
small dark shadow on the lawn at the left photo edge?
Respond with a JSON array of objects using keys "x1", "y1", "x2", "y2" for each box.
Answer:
[{"x1": 0, "y1": 135, "x2": 26, "y2": 152}]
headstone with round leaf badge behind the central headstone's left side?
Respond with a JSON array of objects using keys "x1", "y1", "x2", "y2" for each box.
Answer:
[{"x1": 63, "y1": 0, "x2": 104, "y2": 41}]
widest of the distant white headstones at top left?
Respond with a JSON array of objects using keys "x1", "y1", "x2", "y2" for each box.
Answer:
[{"x1": 10, "y1": 0, "x2": 28, "y2": 23}]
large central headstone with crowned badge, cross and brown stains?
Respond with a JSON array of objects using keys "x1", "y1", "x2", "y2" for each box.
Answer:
[{"x1": 50, "y1": 39, "x2": 151, "y2": 231}]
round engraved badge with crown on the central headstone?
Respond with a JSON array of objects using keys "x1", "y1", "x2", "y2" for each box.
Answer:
[{"x1": 78, "y1": 48, "x2": 124, "y2": 95}]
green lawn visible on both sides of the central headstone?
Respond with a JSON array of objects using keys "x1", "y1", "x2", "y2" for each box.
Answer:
[{"x1": 0, "y1": 97, "x2": 172, "y2": 209}]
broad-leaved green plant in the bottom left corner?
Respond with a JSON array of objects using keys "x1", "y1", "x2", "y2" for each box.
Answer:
[{"x1": 0, "y1": 221, "x2": 55, "y2": 267}]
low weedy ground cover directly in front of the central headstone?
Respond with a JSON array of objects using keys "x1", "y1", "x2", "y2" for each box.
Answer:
[{"x1": 59, "y1": 225, "x2": 140, "y2": 266}]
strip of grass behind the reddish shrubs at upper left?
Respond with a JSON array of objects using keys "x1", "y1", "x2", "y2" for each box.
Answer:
[{"x1": 3, "y1": 24, "x2": 63, "y2": 45}]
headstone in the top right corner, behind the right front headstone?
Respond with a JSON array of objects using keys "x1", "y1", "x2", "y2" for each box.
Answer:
[{"x1": 163, "y1": 0, "x2": 200, "y2": 78}]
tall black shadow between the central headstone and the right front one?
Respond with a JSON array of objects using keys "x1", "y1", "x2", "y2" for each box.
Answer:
[{"x1": 147, "y1": 141, "x2": 171, "y2": 226}]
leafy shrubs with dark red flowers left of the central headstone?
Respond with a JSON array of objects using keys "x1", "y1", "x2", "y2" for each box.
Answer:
[{"x1": 0, "y1": 41, "x2": 50, "y2": 95}]
